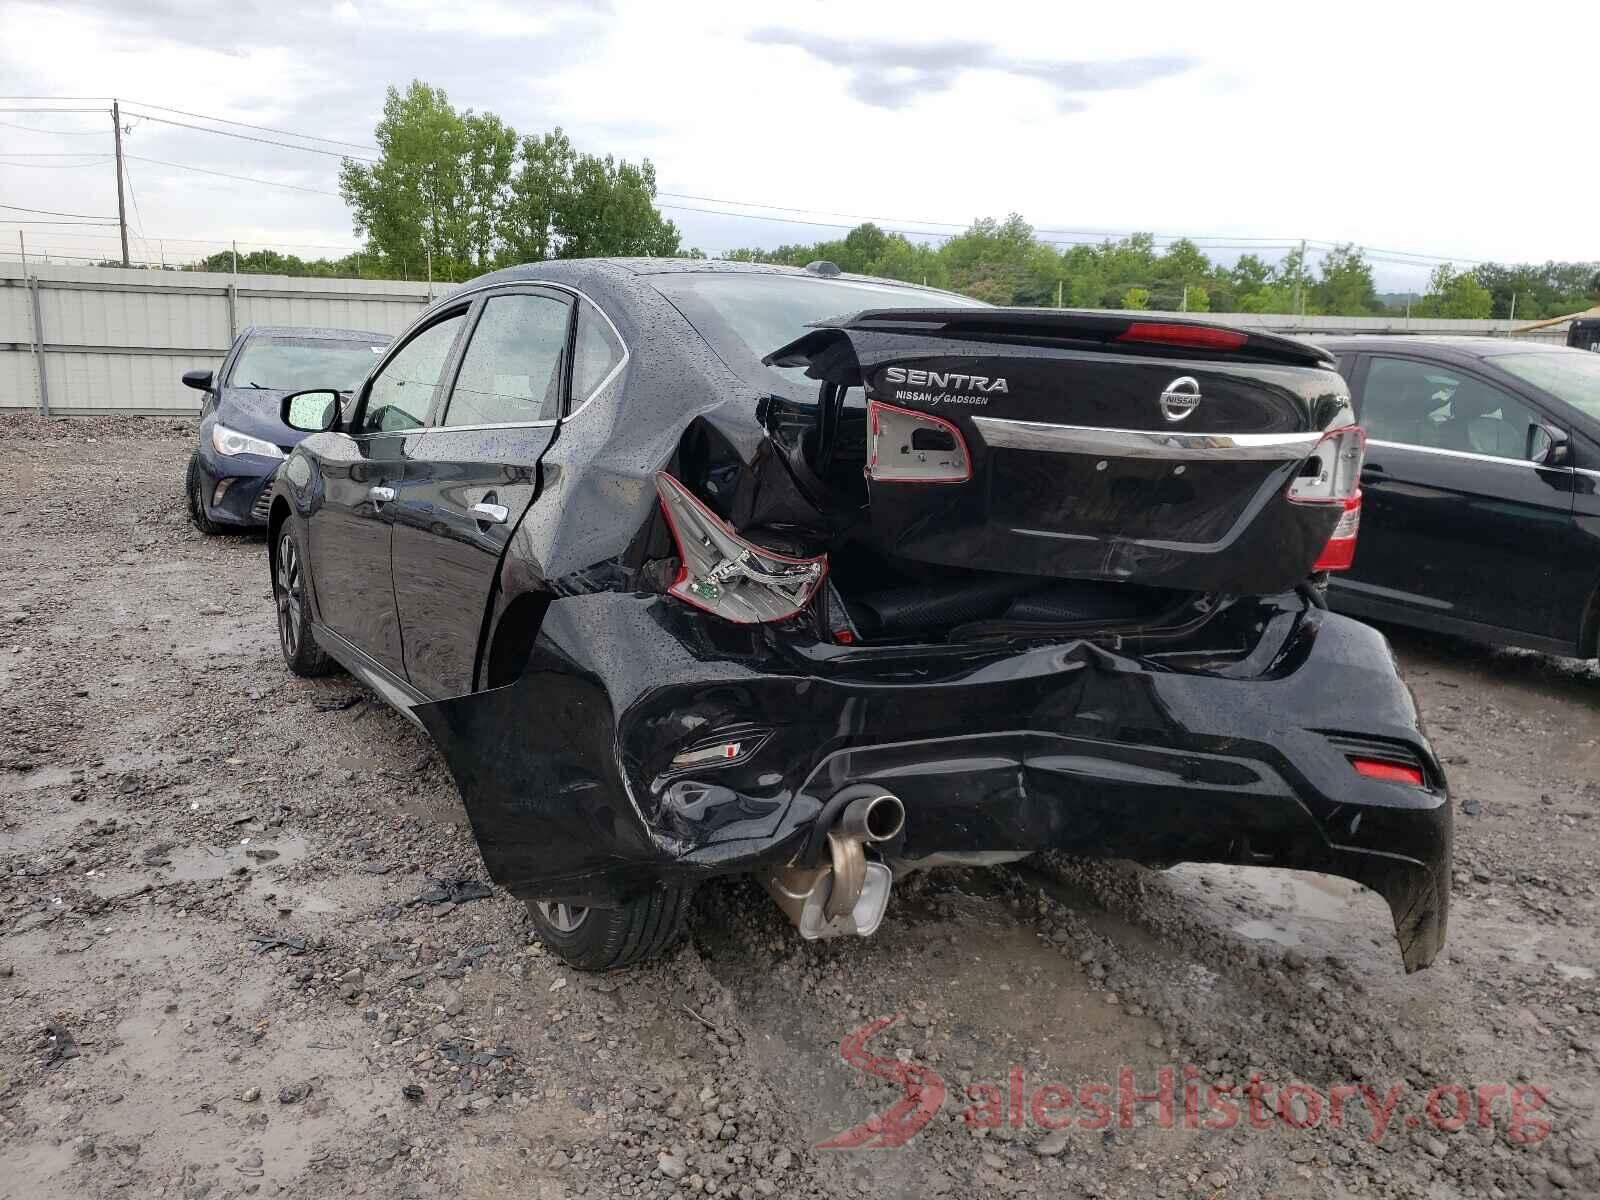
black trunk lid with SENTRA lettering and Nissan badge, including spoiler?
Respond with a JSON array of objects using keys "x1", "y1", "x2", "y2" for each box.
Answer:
[{"x1": 766, "y1": 309, "x2": 1360, "y2": 594}]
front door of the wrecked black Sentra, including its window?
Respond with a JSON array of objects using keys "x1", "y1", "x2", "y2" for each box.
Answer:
[{"x1": 309, "y1": 306, "x2": 467, "y2": 678}]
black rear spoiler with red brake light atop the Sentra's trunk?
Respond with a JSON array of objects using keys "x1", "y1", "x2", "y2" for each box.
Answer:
[{"x1": 762, "y1": 307, "x2": 1336, "y2": 370}]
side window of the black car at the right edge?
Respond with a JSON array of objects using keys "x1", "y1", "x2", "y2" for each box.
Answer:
[{"x1": 1362, "y1": 355, "x2": 1538, "y2": 459}]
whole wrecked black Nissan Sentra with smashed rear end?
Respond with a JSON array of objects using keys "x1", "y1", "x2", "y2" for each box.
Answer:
[{"x1": 267, "y1": 259, "x2": 1451, "y2": 970}]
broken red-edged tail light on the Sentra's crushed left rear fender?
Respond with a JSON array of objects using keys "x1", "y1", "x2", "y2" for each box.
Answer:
[{"x1": 656, "y1": 470, "x2": 827, "y2": 624}]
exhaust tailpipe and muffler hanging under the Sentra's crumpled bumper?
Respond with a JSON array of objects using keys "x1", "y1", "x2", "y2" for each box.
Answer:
[{"x1": 762, "y1": 789, "x2": 906, "y2": 941}]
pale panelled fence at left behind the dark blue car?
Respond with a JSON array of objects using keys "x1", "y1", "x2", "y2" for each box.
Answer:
[{"x1": 0, "y1": 262, "x2": 450, "y2": 416}]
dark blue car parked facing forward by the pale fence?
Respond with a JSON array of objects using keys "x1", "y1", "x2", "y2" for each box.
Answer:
[{"x1": 184, "y1": 326, "x2": 390, "y2": 533}]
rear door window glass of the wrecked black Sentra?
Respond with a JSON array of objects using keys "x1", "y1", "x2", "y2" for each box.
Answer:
[{"x1": 445, "y1": 293, "x2": 570, "y2": 426}]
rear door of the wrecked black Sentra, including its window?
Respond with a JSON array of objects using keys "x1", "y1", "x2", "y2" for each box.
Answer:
[{"x1": 394, "y1": 285, "x2": 573, "y2": 699}]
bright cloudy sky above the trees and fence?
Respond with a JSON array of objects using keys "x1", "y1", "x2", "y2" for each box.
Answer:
[{"x1": 0, "y1": 0, "x2": 1600, "y2": 288}]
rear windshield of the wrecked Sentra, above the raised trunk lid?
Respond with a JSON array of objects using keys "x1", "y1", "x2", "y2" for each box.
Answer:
[{"x1": 651, "y1": 270, "x2": 987, "y2": 392}]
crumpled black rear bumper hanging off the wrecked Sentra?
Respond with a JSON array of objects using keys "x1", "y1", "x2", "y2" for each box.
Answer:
[{"x1": 416, "y1": 594, "x2": 1451, "y2": 970}]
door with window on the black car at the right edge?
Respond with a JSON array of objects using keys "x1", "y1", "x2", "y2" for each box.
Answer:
[{"x1": 1331, "y1": 352, "x2": 1576, "y2": 637}]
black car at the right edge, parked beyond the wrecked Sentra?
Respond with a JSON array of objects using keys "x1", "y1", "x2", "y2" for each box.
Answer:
[{"x1": 1323, "y1": 338, "x2": 1600, "y2": 658}]
